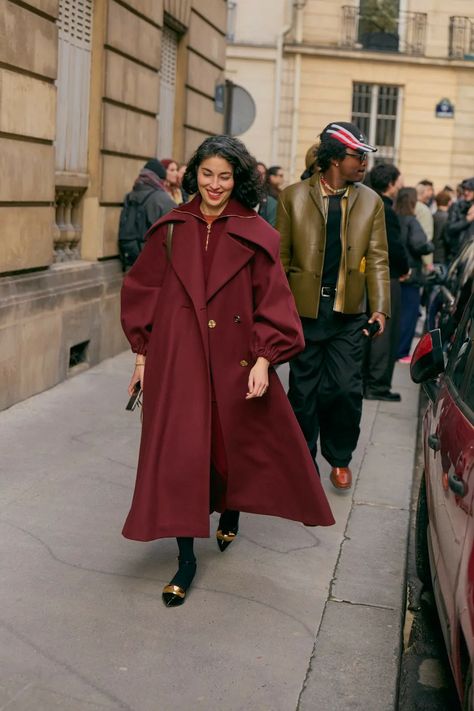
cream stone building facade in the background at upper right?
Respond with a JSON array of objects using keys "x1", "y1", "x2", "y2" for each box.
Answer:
[{"x1": 226, "y1": 0, "x2": 474, "y2": 188}]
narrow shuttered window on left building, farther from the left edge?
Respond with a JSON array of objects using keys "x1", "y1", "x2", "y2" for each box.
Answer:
[{"x1": 158, "y1": 25, "x2": 179, "y2": 158}]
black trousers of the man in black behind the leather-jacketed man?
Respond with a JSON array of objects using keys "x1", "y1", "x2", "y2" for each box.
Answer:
[{"x1": 364, "y1": 279, "x2": 401, "y2": 395}]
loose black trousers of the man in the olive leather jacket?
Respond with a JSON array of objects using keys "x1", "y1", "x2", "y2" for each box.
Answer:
[{"x1": 288, "y1": 297, "x2": 367, "y2": 467}]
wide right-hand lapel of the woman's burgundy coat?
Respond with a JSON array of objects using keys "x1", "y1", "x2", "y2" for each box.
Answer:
[{"x1": 206, "y1": 217, "x2": 255, "y2": 301}]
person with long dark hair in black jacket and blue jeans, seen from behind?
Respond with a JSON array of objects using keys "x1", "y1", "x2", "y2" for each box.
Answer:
[{"x1": 395, "y1": 188, "x2": 434, "y2": 359}]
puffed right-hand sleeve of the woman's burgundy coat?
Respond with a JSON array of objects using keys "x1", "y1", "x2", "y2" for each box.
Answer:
[{"x1": 248, "y1": 243, "x2": 304, "y2": 365}]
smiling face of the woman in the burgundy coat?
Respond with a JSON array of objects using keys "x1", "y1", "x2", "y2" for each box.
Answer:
[{"x1": 197, "y1": 156, "x2": 234, "y2": 215}]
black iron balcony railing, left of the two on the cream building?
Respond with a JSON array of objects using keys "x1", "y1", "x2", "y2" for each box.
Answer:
[{"x1": 341, "y1": 5, "x2": 428, "y2": 56}]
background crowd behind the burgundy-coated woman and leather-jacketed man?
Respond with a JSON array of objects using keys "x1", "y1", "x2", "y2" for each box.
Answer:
[{"x1": 119, "y1": 144, "x2": 474, "y2": 401}]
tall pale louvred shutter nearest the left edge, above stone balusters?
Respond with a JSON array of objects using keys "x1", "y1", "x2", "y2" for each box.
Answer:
[{"x1": 56, "y1": 0, "x2": 92, "y2": 173}]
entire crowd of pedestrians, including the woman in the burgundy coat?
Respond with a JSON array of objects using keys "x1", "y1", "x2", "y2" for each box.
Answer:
[{"x1": 119, "y1": 128, "x2": 474, "y2": 607}]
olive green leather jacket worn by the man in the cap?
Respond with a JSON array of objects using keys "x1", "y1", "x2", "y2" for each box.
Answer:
[{"x1": 276, "y1": 173, "x2": 390, "y2": 318}]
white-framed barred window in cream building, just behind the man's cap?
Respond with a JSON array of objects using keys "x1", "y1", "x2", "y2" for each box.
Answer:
[{"x1": 352, "y1": 83, "x2": 400, "y2": 168}]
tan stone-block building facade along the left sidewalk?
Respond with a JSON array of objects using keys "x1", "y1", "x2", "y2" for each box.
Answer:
[{"x1": 0, "y1": 0, "x2": 227, "y2": 409}]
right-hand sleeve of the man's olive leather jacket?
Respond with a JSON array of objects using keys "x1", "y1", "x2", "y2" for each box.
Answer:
[{"x1": 366, "y1": 200, "x2": 390, "y2": 316}]
